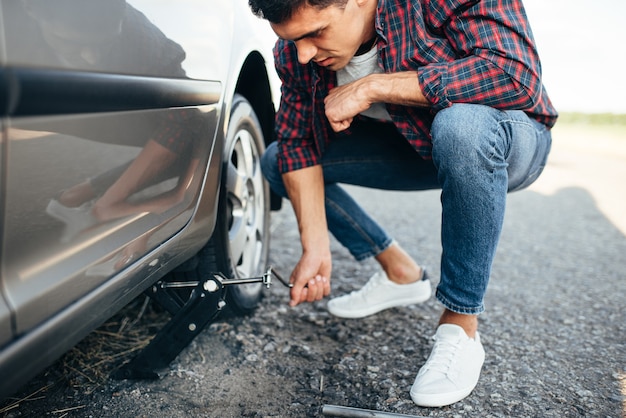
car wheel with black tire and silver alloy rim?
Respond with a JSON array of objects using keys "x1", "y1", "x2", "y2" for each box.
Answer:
[{"x1": 166, "y1": 95, "x2": 270, "y2": 315}]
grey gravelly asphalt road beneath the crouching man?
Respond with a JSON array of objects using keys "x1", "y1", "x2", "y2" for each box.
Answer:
[{"x1": 0, "y1": 125, "x2": 626, "y2": 418}]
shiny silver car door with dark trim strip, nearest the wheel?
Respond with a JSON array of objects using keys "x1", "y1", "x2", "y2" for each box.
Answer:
[{"x1": 0, "y1": 0, "x2": 230, "y2": 335}]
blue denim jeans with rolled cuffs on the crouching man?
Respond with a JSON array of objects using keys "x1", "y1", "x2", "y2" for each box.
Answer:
[{"x1": 261, "y1": 104, "x2": 552, "y2": 314}]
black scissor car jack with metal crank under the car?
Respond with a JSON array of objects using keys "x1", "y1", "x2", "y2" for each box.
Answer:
[{"x1": 111, "y1": 267, "x2": 293, "y2": 380}]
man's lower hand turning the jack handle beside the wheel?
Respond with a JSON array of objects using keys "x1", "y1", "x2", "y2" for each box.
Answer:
[{"x1": 289, "y1": 248, "x2": 332, "y2": 306}]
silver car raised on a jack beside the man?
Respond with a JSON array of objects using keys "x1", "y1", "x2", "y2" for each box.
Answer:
[{"x1": 0, "y1": 0, "x2": 279, "y2": 398}]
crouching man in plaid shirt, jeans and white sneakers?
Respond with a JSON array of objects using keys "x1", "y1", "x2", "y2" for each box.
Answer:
[{"x1": 249, "y1": 0, "x2": 557, "y2": 406}]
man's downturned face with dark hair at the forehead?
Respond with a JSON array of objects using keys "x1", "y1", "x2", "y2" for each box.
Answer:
[{"x1": 271, "y1": 0, "x2": 374, "y2": 71}]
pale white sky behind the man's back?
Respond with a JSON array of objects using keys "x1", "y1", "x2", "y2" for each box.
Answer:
[{"x1": 524, "y1": 0, "x2": 626, "y2": 113}]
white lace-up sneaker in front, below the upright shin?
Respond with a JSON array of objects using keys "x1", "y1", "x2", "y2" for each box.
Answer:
[{"x1": 411, "y1": 324, "x2": 485, "y2": 407}]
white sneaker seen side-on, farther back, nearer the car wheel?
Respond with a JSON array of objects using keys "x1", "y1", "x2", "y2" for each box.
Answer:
[{"x1": 328, "y1": 271, "x2": 431, "y2": 318}]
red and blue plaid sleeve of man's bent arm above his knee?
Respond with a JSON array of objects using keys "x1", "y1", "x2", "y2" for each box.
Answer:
[{"x1": 418, "y1": 0, "x2": 542, "y2": 110}]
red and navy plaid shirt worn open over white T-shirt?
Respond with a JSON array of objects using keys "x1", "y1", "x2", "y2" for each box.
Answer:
[{"x1": 274, "y1": 0, "x2": 557, "y2": 173}]
